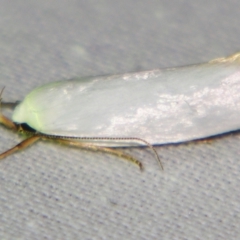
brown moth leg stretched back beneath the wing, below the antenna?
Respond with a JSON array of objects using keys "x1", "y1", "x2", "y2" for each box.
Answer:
[{"x1": 54, "y1": 138, "x2": 143, "y2": 171}]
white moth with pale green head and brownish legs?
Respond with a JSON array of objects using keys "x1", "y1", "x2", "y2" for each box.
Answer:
[{"x1": 0, "y1": 53, "x2": 240, "y2": 167}]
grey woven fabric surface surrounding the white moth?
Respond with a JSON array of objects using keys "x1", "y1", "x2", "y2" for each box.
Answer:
[{"x1": 0, "y1": 0, "x2": 240, "y2": 240}]
